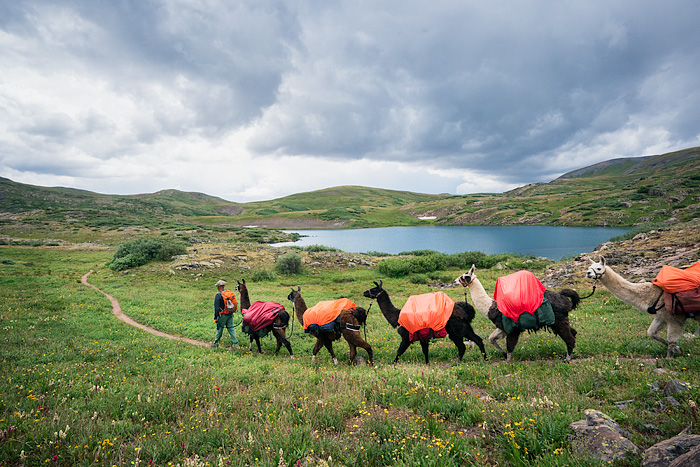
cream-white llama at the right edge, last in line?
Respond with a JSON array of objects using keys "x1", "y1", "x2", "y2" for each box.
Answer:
[{"x1": 586, "y1": 256, "x2": 700, "y2": 358}]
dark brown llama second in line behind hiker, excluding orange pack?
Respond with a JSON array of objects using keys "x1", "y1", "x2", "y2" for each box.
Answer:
[{"x1": 287, "y1": 286, "x2": 374, "y2": 365}]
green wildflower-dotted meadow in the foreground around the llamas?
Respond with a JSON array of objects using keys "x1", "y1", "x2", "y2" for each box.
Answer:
[{"x1": 0, "y1": 245, "x2": 700, "y2": 466}]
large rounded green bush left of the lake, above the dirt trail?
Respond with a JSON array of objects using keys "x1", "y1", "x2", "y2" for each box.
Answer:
[{"x1": 107, "y1": 238, "x2": 187, "y2": 271}]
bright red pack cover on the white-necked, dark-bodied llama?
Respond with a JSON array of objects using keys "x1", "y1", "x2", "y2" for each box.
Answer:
[{"x1": 493, "y1": 271, "x2": 546, "y2": 321}]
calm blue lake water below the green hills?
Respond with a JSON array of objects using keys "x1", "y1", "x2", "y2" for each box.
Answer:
[{"x1": 275, "y1": 225, "x2": 629, "y2": 260}]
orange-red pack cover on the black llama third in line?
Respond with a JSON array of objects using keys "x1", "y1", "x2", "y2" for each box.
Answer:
[{"x1": 399, "y1": 292, "x2": 455, "y2": 333}]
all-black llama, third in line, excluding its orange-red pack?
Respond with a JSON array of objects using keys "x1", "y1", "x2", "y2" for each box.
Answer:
[{"x1": 364, "y1": 280, "x2": 486, "y2": 365}]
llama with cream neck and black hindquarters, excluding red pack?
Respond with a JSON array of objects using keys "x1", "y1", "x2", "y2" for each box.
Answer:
[{"x1": 455, "y1": 264, "x2": 581, "y2": 362}]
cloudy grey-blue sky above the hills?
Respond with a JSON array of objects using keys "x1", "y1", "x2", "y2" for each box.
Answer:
[{"x1": 0, "y1": 0, "x2": 700, "y2": 202}]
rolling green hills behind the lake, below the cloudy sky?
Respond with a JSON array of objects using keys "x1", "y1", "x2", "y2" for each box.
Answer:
[{"x1": 0, "y1": 148, "x2": 700, "y2": 240}]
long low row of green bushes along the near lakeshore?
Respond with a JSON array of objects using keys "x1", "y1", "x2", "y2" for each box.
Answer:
[{"x1": 377, "y1": 250, "x2": 513, "y2": 278}]
